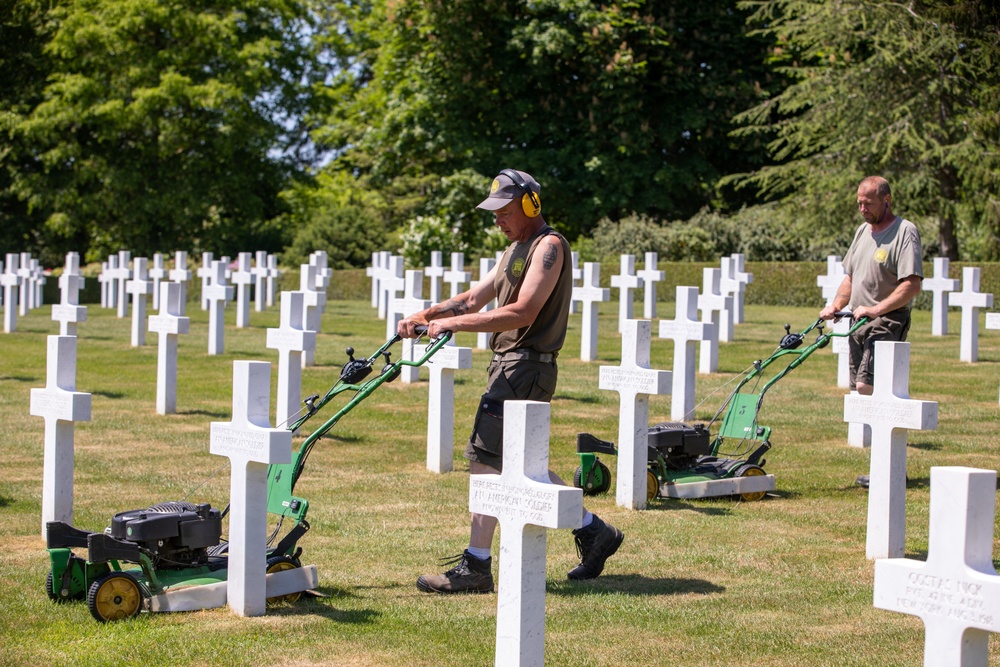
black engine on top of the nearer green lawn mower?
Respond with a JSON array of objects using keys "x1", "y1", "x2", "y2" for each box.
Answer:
[{"x1": 96, "y1": 501, "x2": 222, "y2": 569}]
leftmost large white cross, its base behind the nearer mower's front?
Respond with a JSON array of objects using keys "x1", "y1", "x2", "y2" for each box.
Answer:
[{"x1": 30, "y1": 336, "x2": 90, "y2": 537}]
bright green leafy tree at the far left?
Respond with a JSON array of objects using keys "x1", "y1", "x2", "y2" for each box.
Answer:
[{"x1": 4, "y1": 0, "x2": 325, "y2": 260}]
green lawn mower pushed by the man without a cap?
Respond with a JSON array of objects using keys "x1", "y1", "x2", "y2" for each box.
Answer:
[{"x1": 573, "y1": 311, "x2": 867, "y2": 501}]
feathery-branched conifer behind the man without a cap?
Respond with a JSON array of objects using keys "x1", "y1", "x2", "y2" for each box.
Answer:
[{"x1": 730, "y1": 0, "x2": 1000, "y2": 259}]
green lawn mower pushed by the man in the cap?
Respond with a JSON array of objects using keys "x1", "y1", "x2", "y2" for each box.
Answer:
[{"x1": 45, "y1": 334, "x2": 451, "y2": 622}]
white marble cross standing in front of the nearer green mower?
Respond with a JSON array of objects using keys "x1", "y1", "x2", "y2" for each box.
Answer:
[{"x1": 210, "y1": 362, "x2": 292, "y2": 616}]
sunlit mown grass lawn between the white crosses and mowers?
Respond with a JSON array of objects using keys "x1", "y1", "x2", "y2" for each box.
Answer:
[{"x1": 0, "y1": 301, "x2": 1000, "y2": 667}]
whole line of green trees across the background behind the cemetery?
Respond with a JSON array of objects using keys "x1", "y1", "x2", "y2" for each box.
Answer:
[{"x1": 0, "y1": 0, "x2": 1000, "y2": 267}]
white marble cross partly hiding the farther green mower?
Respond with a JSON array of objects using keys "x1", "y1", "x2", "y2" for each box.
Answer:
[{"x1": 599, "y1": 320, "x2": 671, "y2": 510}]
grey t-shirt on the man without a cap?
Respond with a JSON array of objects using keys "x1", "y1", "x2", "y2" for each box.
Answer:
[{"x1": 844, "y1": 216, "x2": 924, "y2": 310}]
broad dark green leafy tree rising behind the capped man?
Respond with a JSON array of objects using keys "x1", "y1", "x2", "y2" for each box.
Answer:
[{"x1": 317, "y1": 0, "x2": 777, "y2": 236}]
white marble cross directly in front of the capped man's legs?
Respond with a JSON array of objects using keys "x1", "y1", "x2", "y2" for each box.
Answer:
[{"x1": 469, "y1": 401, "x2": 583, "y2": 667}]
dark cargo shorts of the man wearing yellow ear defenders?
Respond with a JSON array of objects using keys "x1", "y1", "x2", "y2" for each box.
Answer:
[{"x1": 465, "y1": 359, "x2": 558, "y2": 470}]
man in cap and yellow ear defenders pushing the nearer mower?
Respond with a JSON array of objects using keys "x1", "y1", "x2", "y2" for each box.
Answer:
[{"x1": 398, "y1": 169, "x2": 624, "y2": 593}]
